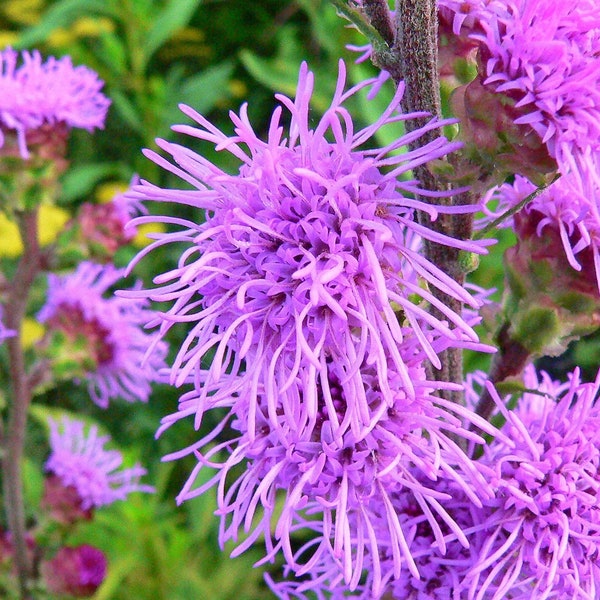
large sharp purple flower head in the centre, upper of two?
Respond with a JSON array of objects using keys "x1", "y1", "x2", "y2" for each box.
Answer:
[{"x1": 126, "y1": 58, "x2": 484, "y2": 437}]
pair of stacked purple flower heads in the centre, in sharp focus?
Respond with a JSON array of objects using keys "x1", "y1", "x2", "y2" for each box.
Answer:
[{"x1": 129, "y1": 58, "x2": 502, "y2": 596}]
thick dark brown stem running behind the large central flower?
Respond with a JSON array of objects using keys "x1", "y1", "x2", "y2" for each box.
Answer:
[{"x1": 390, "y1": 0, "x2": 473, "y2": 402}]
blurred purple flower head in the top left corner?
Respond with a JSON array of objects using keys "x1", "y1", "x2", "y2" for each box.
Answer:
[{"x1": 0, "y1": 48, "x2": 110, "y2": 159}]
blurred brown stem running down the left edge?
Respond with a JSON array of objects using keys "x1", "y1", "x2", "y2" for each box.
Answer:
[{"x1": 2, "y1": 210, "x2": 41, "y2": 600}]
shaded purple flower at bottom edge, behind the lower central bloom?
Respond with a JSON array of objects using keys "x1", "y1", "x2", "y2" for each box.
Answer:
[{"x1": 267, "y1": 474, "x2": 486, "y2": 600}]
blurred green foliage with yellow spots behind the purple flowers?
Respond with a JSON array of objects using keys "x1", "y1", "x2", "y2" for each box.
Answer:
[{"x1": 0, "y1": 0, "x2": 597, "y2": 600}]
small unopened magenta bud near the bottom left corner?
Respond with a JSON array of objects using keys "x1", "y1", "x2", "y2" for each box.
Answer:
[{"x1": 41, "y1": 544, "x2": 106, "y2": 598}]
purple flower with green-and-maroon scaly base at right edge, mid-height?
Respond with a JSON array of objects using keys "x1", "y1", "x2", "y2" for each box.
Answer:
[{"x1": 483, "y1": 175, "x2": 600, "y2": 356}]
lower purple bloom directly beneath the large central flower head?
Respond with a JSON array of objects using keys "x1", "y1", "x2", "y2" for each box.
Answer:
[{"x1": 165, "y1": 334, "x2": 494, "y2": 597}]
